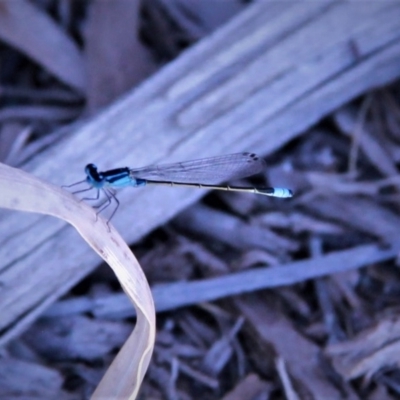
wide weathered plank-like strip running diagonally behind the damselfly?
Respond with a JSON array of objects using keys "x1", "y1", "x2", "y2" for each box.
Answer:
[{"x1": 0, "y1": 1, "x2": 400, "y2": 343}]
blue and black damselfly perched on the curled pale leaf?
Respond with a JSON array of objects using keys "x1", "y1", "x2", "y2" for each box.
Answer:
[{"x1": 69, "y1": 153, "x2": 293, "y2": 222}]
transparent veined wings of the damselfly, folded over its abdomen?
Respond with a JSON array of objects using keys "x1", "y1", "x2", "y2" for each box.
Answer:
[{"x1": 130, "y1": 153, "x2": 266, "y2": 184}]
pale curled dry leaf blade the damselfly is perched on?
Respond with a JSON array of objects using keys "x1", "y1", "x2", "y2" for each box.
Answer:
[{"x1": 0, "y1": 164, "x2": 155, "y2": 399}]
